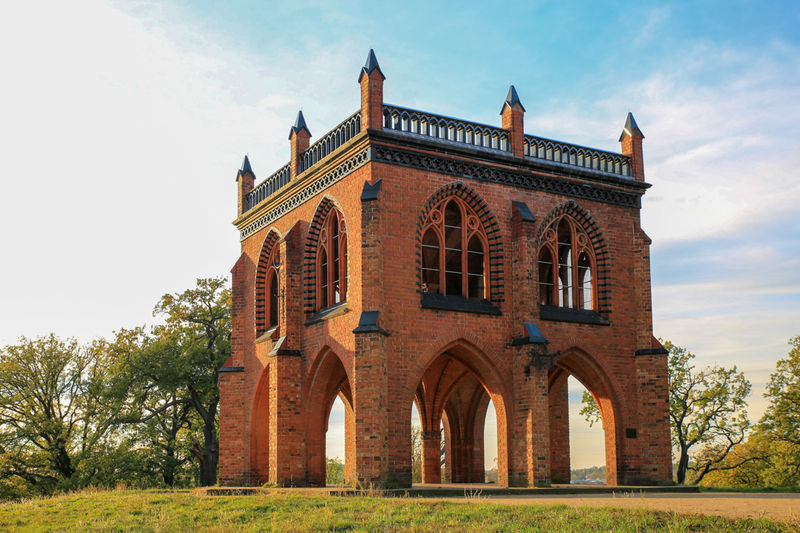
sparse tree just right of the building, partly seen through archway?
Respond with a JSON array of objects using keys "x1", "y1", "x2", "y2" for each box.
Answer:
[{"x1": 581, "y1": 341, "x2": 756, "y2": 484}]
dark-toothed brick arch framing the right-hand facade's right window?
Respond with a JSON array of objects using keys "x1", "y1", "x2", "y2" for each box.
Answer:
[{"x1": 536, "y1": 200, "x2": 611, "y2": 314}]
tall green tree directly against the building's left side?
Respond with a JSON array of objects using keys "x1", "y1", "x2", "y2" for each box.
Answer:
[{"x1": 148, "y1": 278, "x2": 231, "y2": 486}]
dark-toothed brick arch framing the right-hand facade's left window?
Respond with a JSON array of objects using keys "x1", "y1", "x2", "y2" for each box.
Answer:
[{"x1": 415, "y1": 181, "x2": 504, "y2": 304}]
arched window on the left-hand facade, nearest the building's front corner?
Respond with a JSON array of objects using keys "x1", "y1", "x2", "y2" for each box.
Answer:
[{"x1": 317, "y1": 209, "x2": 347, "y2": 309}]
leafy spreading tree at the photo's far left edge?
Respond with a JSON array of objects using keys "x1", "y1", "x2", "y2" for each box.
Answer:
[{"x1": 0, "y1": 334, "x2": 125, "y2": 493}]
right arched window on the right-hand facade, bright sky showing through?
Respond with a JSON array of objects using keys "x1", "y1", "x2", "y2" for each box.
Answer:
[{"x1": 538, "y1": 215, "x2": 597, "y2": 309}]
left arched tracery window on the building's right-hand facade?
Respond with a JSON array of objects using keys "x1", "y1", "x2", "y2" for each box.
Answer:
[{"x1": 422, "y1": 198, "x2": 489, "y2": 299}]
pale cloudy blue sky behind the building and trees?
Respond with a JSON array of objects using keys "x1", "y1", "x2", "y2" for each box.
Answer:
[{"x1": 0, "y1": 0, "x2": 800, "y2": 467}]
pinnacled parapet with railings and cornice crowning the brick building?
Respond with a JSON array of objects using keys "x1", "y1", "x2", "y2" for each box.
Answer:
[{"x1": 235, "y1": 50, "x2": 649, "y2": 239}]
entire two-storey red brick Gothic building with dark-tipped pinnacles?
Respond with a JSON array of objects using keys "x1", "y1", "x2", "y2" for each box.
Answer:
[{"x1": 219, "y1": 51, "x2": 672, "y2": 486}]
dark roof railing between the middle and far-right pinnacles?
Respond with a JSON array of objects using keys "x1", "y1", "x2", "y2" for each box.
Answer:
[{"x1": 523, "y1": 135, "x2": 631, "y2": 176}]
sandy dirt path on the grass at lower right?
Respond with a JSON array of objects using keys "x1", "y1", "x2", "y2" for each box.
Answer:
[{"x1": 462, "y1": 492, "x2": 800, "y2": 524}]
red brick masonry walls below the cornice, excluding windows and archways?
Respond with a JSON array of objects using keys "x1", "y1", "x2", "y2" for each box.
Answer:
[{"x1": 220, "y1": 124, "x2": 671, "y2": 485}]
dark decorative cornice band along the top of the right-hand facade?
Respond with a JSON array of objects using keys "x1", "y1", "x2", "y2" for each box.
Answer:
[{"x1": 372, "y1": 145, "x2": 641, "y2": 209}]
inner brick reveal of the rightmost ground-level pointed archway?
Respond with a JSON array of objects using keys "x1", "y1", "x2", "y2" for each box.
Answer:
[{"x1": 548, "y1": 349, "x2": 622, "y2": 485}]
